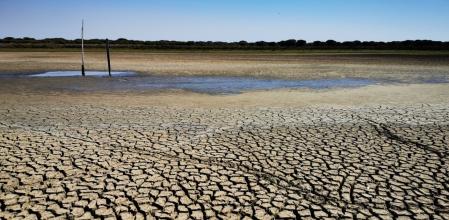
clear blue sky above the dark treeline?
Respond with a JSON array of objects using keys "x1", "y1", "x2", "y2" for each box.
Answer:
[{"x1": 0, "y1": 0, "x2": 449, "y2": 41}]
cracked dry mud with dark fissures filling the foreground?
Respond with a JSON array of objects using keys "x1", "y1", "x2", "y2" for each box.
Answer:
[{"x1": 0, "y1": 104, "x2": 449, "y2": 219}]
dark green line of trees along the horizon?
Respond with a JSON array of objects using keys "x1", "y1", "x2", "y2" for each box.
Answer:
[{"x1": 0, "y1": 37, "x2": 449, "y2": 50}]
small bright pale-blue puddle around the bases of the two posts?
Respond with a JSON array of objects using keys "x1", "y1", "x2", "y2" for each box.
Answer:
[{"x1": 28, "y1": 71, "x2": 136, "y2": 77}]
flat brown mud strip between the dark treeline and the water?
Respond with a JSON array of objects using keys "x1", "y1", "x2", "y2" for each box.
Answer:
[{"x1": 0, "y1": 49, "x2": 449, "y2": 80}]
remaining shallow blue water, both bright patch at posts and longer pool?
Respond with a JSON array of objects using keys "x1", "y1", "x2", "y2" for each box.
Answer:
[{"x1": 28, "y1": 71, "x2": 377, "y2": 94}]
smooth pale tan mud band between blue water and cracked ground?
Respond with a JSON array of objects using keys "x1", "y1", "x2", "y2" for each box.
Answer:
[{"x1": 0, "y1": 84, "x2": 449, "y2": 108}]
